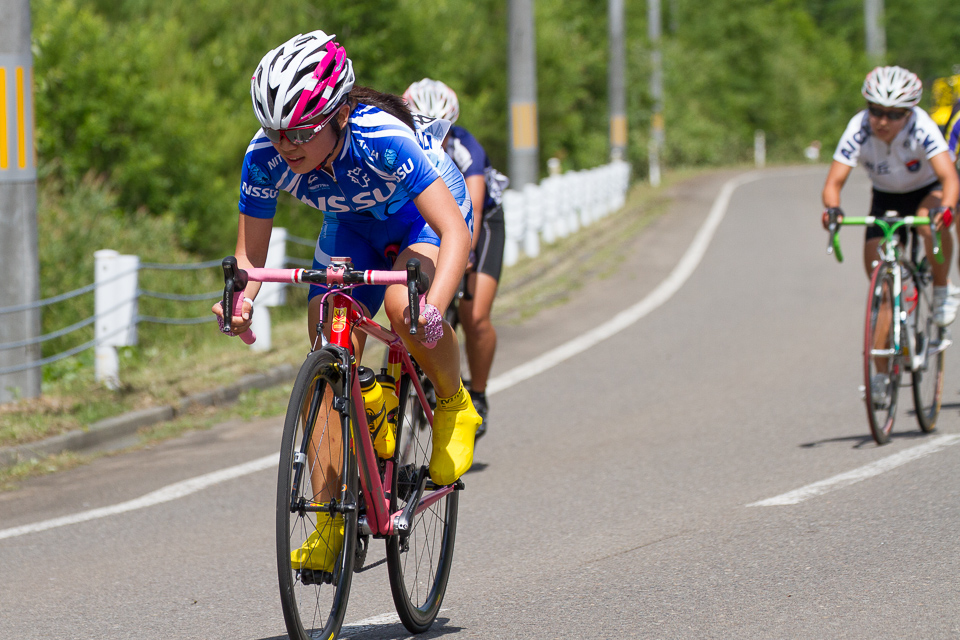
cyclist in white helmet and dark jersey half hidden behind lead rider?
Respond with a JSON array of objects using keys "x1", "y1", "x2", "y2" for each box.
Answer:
[{"x1": 403, "y1": 78, "x2": 509, "y2": 438}]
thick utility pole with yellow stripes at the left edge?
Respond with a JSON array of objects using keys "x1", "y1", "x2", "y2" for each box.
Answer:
[{"x1": 0, "y1": 0, "x2": 40, "y2": 403}]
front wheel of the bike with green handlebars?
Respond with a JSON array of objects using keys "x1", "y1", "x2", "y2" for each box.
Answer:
[{"x1": 863, "y1": 263, "x2": 902, "y2": 444}]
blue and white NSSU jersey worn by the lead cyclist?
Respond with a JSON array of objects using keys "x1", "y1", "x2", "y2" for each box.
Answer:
[{"x1": 240, "y1": 105, "x2": 472, "y2": 227}]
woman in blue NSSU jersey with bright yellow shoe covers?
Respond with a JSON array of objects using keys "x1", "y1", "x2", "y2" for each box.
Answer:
[{"x1": 214, "y1": 31, "x2": 481, "y2": 570}]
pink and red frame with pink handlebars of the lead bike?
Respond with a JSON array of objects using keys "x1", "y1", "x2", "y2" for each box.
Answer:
[{"x1": 224, "y1": 258, "x2": 461, "y2": 537}]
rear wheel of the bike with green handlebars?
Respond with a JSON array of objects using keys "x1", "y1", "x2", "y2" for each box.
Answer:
[{"x1": 910, "y1": 272, "x2": 946, "y2": 433}]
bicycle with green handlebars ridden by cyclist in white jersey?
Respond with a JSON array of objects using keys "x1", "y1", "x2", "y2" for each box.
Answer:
[{"x1": 827, "y1": 211, "x2": 952, "y2": 444}]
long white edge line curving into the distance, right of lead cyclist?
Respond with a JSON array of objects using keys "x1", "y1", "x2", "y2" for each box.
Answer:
[{"x1": 487, "y1": 173, "x2": 763, "y2": 395}]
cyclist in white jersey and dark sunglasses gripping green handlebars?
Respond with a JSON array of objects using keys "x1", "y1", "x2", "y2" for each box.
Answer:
[{"x1": 822, "y1": 66, "x2": 960, "y2": 326}]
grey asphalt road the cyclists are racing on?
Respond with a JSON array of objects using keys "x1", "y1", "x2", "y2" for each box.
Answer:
[{"x1": 0, "y1": 167, "x2": 960, "y2": 640}]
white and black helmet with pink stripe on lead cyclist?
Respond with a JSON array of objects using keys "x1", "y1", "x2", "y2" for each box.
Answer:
[{"x1": 250, "y1": 31, "x2": 354, "y2": 129}]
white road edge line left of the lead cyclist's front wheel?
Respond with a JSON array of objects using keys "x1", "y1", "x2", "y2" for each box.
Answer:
[{"x1": 0, "y1": 453, "x2": 280, "y2": 540}]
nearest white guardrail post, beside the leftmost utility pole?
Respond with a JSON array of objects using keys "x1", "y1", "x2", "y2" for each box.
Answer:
[{"x1": 93, "y1": 249, "x2": 140, "y2": 390}]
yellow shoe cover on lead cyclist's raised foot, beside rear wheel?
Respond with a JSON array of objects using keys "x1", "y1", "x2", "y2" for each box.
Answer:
[{"x1": 430, "y1": 382, "x2": 482, "y2": 485}]
